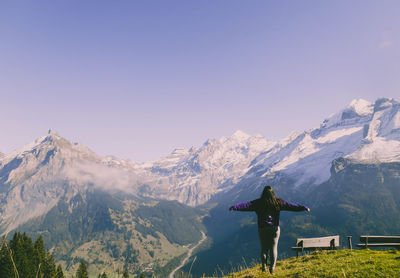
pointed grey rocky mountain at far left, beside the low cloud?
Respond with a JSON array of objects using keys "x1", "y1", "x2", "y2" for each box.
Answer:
[{"x1": 0, "y1": 132, "x2": 100, "y2": 232}]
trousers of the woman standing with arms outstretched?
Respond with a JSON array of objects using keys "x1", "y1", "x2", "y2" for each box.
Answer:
[{"x1": 258, "y1": 226, "x2": 281, "y2": 273}]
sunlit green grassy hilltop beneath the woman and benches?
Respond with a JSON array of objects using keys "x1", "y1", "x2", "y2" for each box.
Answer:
[{"x1": 220, "y1": 249, "x2": 400, "y2": 278}]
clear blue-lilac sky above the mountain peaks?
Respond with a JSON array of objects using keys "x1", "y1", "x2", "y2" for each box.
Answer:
[{"x1": 0, "y1": 0, "x2": 400, "y2": 161}]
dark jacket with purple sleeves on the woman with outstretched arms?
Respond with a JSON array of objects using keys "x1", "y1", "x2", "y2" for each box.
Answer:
[{"x1": 229, "y1": 199, "x2": 308, "y2": 228}]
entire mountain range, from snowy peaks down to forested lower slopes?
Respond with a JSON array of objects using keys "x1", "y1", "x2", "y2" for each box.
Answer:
[{"x1": 0, "y1": 98, "x2": 400, "y2": 275}]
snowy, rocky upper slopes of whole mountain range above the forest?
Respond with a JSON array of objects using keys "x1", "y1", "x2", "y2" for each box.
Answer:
[{"x1": 0, "y1": 96, "x2": 400, "y2": 232}]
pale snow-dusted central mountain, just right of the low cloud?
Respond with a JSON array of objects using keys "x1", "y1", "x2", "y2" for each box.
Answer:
[{"x1": 130, "y1": 131, "x2": 275, "y2": 206}]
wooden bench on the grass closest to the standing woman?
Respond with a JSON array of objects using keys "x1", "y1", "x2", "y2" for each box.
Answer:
[{"x1": 292, "y1": 236, "x2": 340, "y2": 257}]
